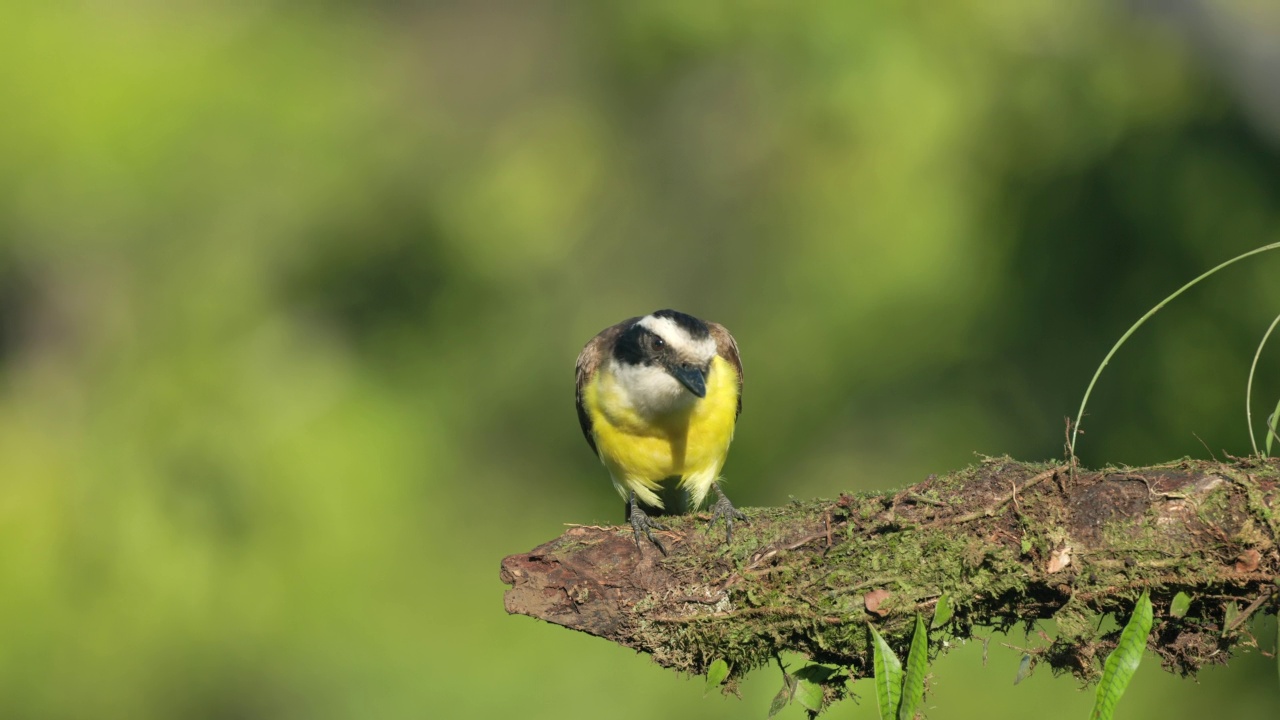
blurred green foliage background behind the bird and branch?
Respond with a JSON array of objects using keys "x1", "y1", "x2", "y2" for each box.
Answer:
[{"x1": 0, "y1": 0, "x2": 1280, "y2": 720}]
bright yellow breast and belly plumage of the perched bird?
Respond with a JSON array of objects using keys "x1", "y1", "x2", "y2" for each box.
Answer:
[{"x1": 584, "y1": 356, "x2": 739, "y2": 505}]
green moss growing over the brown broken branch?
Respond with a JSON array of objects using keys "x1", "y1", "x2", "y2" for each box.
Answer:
[{"x1": 619, "y1": 459, "x2": 1268, "y2": 679}]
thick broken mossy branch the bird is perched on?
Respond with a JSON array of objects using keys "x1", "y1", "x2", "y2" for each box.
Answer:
[{"x1": 502, "y1": 457, "x2": 1280, "y2": 694}]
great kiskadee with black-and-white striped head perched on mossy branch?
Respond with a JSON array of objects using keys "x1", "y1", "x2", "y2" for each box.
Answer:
[{"x1": 577, "y1": 304, "x2": 746, "y2": 555}]
